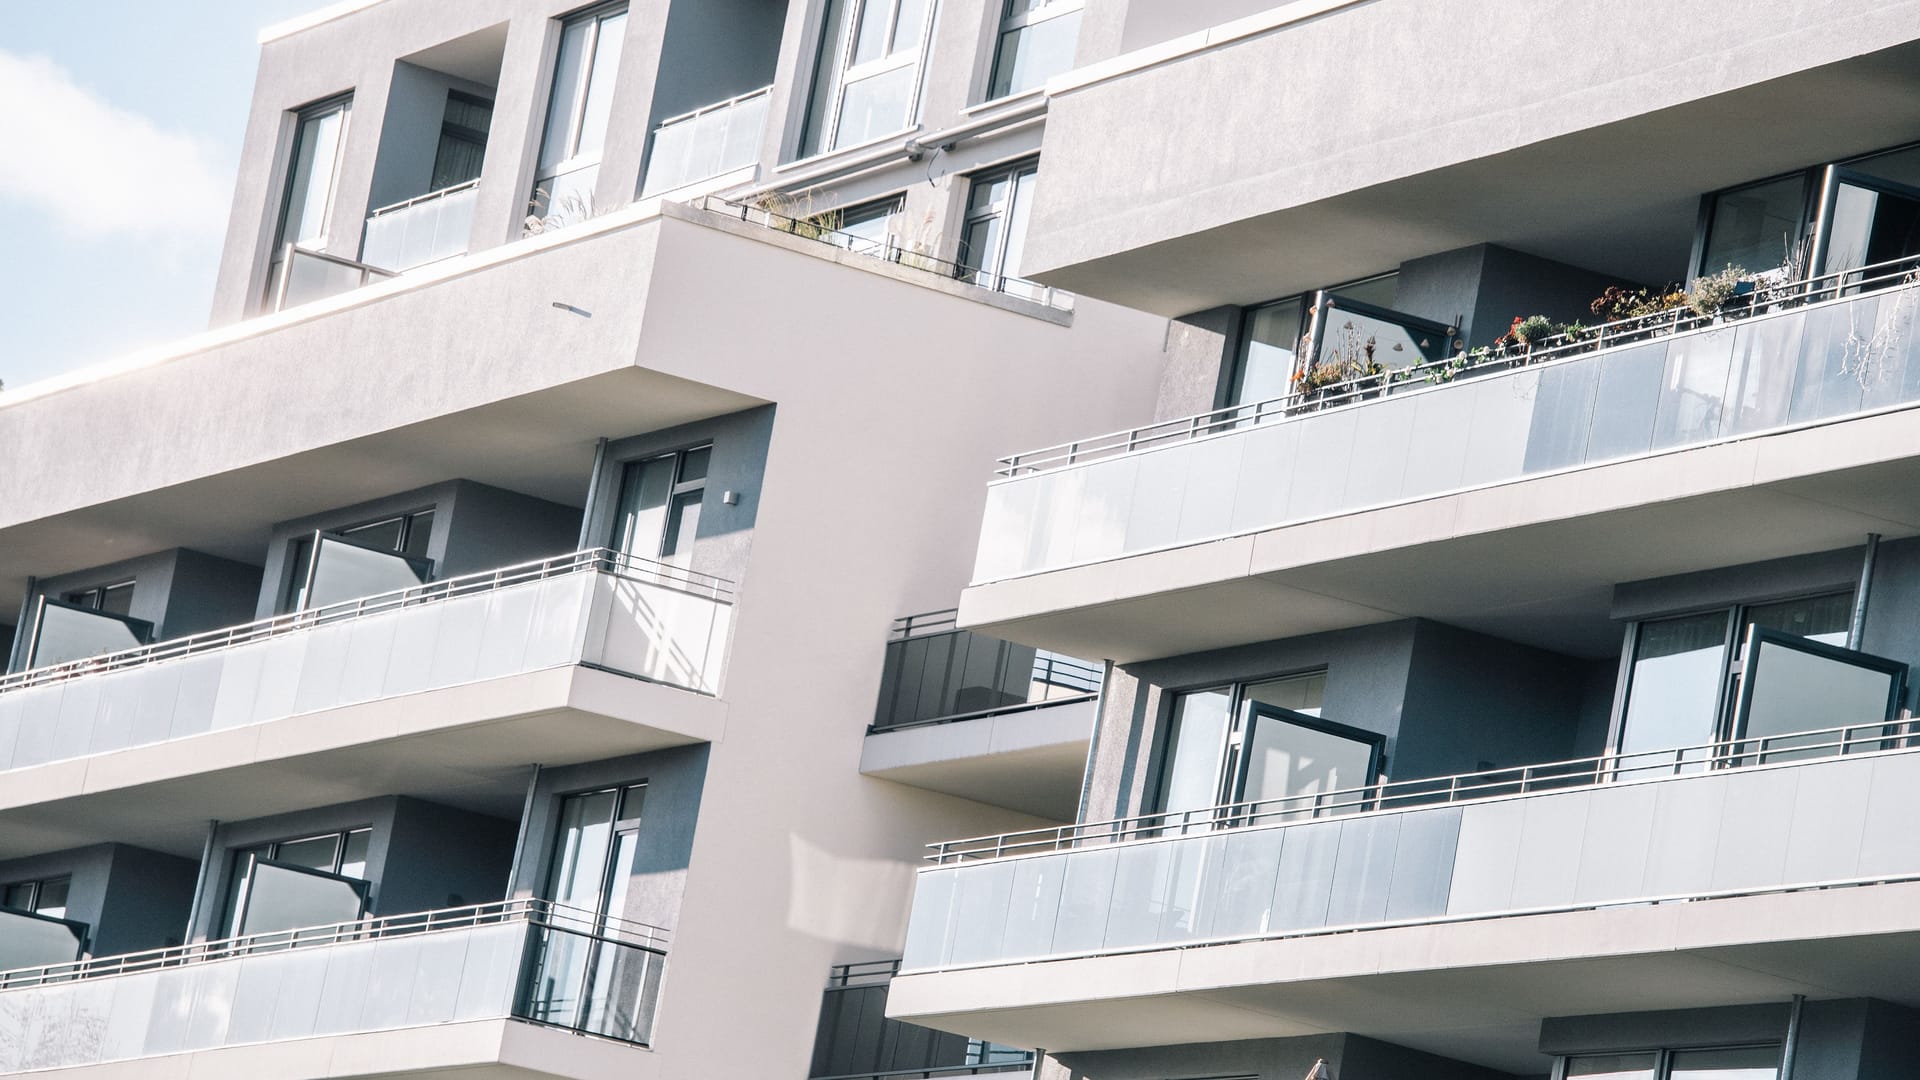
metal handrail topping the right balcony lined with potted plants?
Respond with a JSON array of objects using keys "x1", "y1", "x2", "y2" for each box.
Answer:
[{"x1": 995, "y1": 256, "x2": 1920, "y2": 477}]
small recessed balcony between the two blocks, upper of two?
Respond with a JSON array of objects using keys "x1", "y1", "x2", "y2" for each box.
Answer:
[{"x1": 860, "y1": 609, "x2": 1102, "y2": 821}]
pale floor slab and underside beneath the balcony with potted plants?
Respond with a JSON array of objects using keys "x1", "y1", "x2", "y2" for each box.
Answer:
[{"x1": 960, "y1": 405, "x2": 1920, "y2": 663}]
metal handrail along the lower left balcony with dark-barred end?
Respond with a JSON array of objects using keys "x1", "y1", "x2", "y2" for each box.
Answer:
[{"x1": 0, "y1": 899, "x2": 670, "y2": 990}]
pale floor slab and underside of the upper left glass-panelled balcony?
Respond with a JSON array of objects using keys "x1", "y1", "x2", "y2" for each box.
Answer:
[{"x1": 0, "y1": 667, "x2": 726, "y2": 859}]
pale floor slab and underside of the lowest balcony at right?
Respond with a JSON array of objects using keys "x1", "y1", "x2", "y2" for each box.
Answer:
[{"x1": 887, "y1": 882, "x2": 1920, "y2": 1074}]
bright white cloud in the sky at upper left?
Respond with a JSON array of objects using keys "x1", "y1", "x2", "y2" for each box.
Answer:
[{"x1": 0, "y1": 50, "x2": 232, "y2": 236}]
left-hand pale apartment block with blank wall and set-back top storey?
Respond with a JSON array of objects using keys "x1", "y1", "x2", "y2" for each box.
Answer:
[{"x1": 0, "y1": 0, "x2": 1165, "y2": 1080}]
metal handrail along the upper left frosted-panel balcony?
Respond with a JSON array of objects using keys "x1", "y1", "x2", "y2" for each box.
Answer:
[{"x1": 0, "y1": 548, "x2": 733, "y2": 694}]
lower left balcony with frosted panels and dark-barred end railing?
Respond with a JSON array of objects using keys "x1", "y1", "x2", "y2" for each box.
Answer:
[{"x1": 0, "y1": 899, "x2": 666, "y2": 1076}]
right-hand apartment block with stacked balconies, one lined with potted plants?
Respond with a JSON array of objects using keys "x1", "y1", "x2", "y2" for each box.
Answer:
[{"x1": 889, "y1": 0, "x2": 1920, "y2": 1080}]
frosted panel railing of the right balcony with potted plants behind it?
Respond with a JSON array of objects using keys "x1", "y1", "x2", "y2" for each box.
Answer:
[{"x1": 973, "y1": 259, "x2": 1920, "y2": 582}]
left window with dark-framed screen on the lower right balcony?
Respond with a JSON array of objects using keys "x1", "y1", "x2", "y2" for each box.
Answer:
[{"x1": 1158, "y1": 673, "x2": 1384, "y2": 826}]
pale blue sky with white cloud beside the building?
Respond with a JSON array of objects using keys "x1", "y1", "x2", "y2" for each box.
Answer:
[{"x1": 0, "y1": 0, "x2": 328, "y2": 388}]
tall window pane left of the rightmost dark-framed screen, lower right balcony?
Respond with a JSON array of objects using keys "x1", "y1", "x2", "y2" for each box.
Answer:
[{"x1": 1620, "y1": 611, "x2": 1728, "y2": 765}]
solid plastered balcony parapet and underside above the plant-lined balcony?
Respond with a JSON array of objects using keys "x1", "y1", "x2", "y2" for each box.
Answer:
[{"x1": 1021, "y1": 0, "x2": 1920, "y2": 317}]
